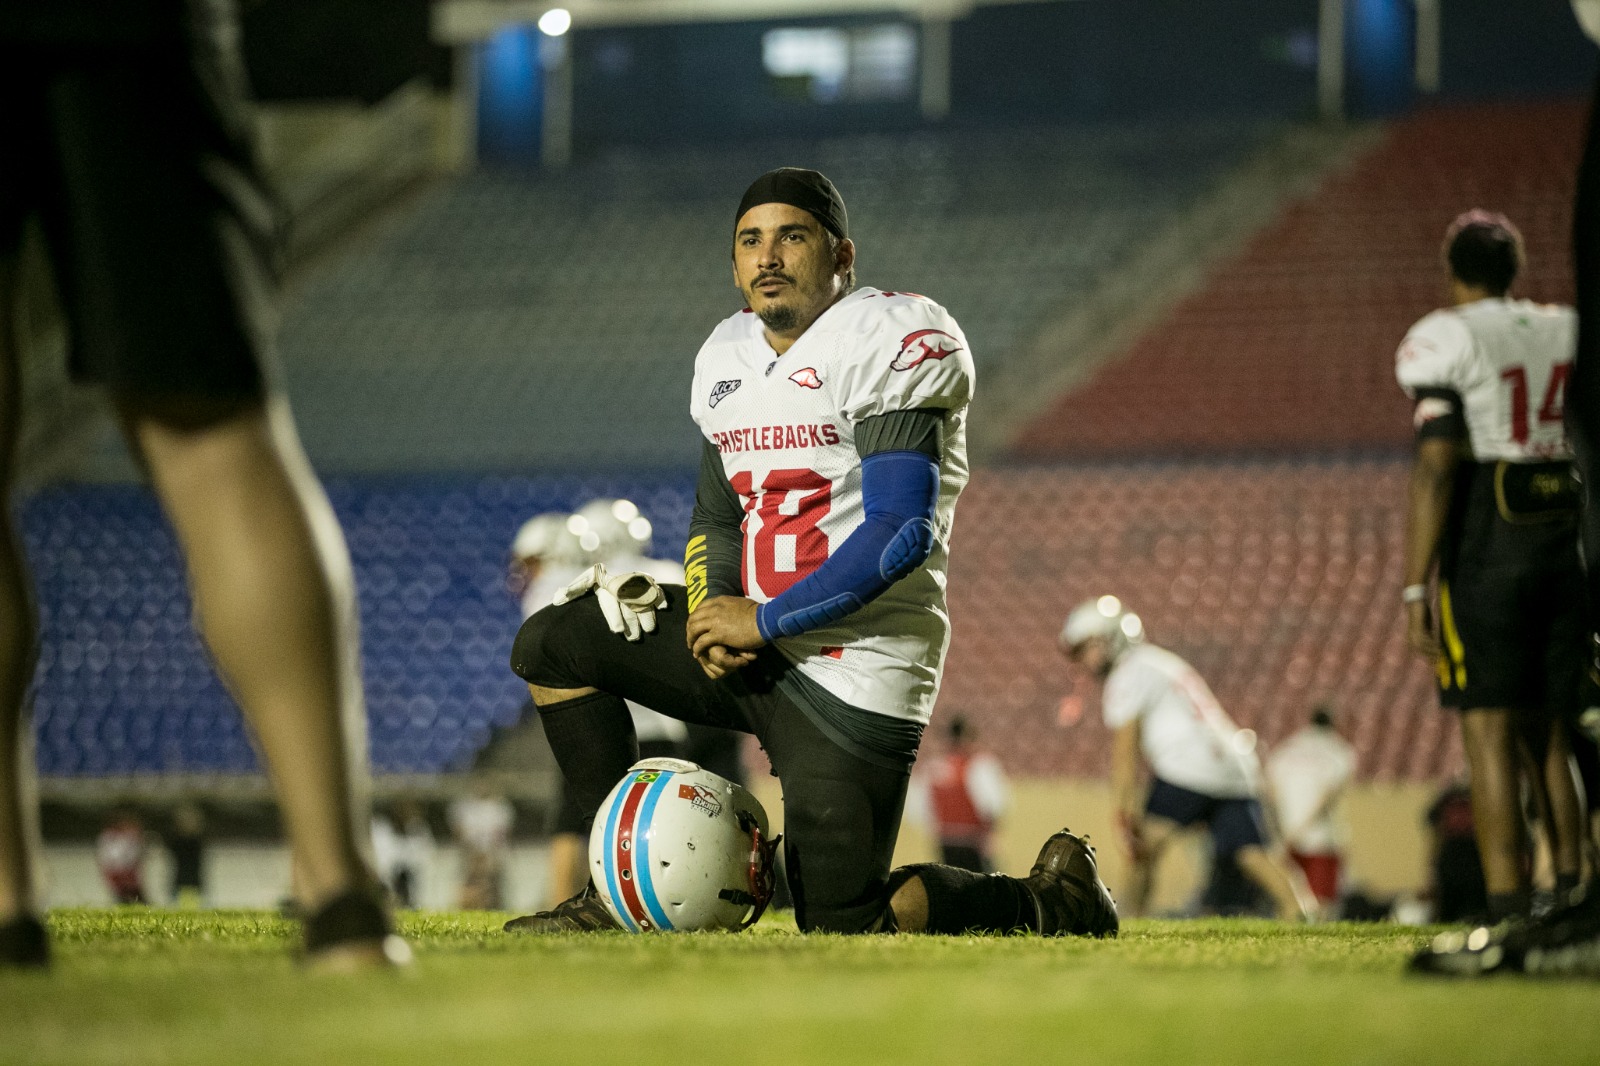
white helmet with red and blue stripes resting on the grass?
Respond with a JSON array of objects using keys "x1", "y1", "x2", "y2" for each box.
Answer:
[{"x1": 589, "y1": 759, "x2": 781, "y2": 933}]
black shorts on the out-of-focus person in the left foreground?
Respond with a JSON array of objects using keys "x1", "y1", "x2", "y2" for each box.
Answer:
[{"x1": 0, "y1": 13, "x2": 277, "y2": 399}]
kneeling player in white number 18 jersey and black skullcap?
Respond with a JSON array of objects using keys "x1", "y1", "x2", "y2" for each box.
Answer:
[{"x1": 509, "y1": 168, "x2": 1117, "y2": 935}]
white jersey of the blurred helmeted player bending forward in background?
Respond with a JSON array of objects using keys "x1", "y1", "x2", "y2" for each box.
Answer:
[{"x1": 1101, "y1": 643, "x2": 1261, "y2": 799}]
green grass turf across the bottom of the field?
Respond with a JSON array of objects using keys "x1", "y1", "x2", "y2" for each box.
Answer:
[{"x1": 0, "y1": 909, "x2": 1600, "y2": 1066}]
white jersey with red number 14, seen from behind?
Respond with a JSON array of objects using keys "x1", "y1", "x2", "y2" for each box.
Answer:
[{"x1": 1395, "y1": 298, "x2": 1578, "y2": 463}]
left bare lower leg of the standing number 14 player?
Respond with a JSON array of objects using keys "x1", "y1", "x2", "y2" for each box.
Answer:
[{"x1": 1461, "y1": 707, "x2": 1528, "y2": 896}]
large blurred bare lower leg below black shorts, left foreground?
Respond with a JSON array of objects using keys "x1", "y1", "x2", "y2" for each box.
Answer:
[{"x1": 118, "y1": 397, "x2": 371, "y2": 911}]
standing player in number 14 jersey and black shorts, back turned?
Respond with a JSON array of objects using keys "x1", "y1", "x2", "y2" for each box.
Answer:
[{"x1": 1395, "y1": 211, "x2": 1586, "y2": 920}]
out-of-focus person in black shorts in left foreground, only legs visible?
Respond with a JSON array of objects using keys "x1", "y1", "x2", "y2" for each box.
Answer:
[{"x1": 0, "y1": 0, "x2": 400, "y2": 967}]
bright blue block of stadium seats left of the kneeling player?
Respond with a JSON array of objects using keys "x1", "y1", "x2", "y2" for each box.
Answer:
[{"x1": 24, "y1": 472, "x2": 694, "y2": 776}]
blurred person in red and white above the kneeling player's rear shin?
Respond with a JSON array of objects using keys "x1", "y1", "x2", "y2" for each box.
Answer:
[{"x1": 907, "y1": 714, "x2": 1011, "y2": 874}]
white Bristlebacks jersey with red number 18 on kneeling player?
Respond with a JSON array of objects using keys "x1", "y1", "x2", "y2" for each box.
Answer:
[{"x1": 690, "y1": 288, "x2": 973, "y2": 722}]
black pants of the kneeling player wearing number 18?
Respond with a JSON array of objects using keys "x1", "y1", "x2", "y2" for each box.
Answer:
[{"x1": 512, "y1": 584, "x2": 910, "y2": 933}]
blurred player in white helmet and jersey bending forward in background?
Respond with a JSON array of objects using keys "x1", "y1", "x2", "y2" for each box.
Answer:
[{"x1": 1061, "y1": 595, "x2": 1314, "y2": 919}]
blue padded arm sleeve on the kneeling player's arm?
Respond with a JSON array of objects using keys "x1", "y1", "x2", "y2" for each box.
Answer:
[{"x1": 755, "y1": 451, "x2": 939, "y2": 640}]
